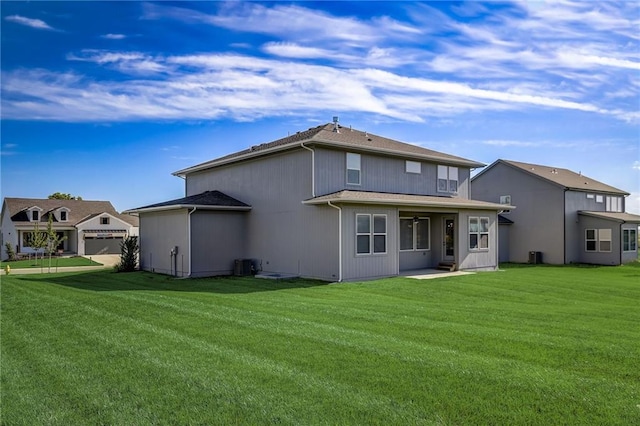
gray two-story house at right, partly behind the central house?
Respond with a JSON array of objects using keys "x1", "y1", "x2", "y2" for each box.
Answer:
[{"x1": 471, "y1": 160, "x2": 640, "y2": 265}]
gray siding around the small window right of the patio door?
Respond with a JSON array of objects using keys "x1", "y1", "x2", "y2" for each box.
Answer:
[{"x1": 456, "y1": 210, "x2": 498, "y2": 271}]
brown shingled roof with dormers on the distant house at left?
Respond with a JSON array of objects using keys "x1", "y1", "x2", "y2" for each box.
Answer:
[{"x1": 4, "y1": 197, "x2": 138, "y2": 226}]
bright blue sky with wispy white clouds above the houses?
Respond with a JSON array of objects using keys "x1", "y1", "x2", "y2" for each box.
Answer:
[{"x1": 0, "y1": 1, "x2": 640, "y2": 213}]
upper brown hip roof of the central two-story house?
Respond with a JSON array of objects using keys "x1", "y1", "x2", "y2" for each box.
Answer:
[{"x1": 173, "y1": 123, "x2": 485, "y2": 176}]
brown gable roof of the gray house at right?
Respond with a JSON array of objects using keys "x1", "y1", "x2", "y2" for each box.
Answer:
[{"x1": 471, "y1": 160, "x2": 629, "y2": 195}]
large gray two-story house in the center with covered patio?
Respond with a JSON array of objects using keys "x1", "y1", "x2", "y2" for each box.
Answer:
[{"x1": 129, "y1": 123, "x2": 504, "y2": 281}]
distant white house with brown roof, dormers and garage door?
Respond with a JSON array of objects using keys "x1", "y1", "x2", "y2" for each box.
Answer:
[{"x1": 1, "y1": 198, "x2": 138, "y2": 259}]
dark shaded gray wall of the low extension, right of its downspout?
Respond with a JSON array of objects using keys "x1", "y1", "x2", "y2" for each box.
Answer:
[{"x1": 191, "y1": 210, "x2": 248, "y2": 277}]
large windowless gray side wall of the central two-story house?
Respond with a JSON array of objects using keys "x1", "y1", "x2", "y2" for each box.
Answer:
[{"x1": 186, "y1": 149, "x2": 338, "y2": 280}]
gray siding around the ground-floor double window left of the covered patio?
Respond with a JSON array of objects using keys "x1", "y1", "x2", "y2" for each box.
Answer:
[{"x1": 342, "y1": 205, "x2": 399, "y2": 281}]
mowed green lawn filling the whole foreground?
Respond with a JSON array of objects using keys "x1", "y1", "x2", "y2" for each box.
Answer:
[{"x1": 1, "y1": 264, "x2": 640, "y2": 425}]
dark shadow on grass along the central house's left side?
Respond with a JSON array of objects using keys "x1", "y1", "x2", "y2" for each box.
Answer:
[{"x1": 11, "y1": 270, "x2": 329, "y2": 294}]
